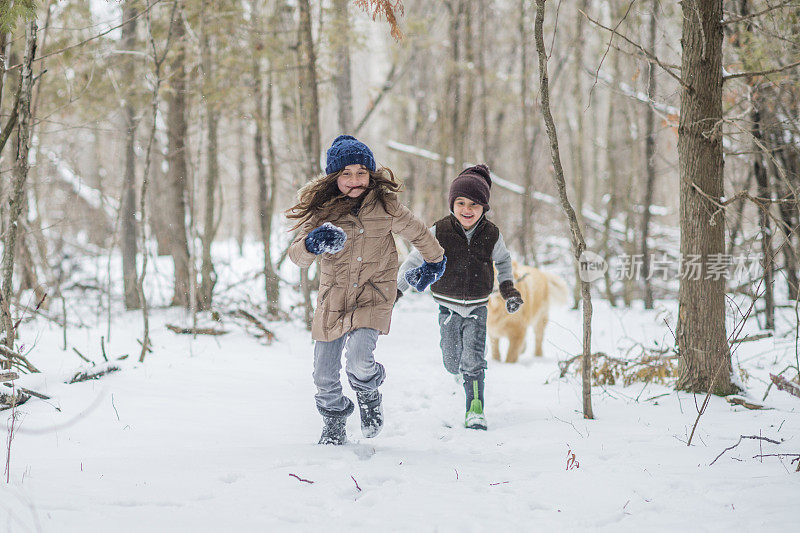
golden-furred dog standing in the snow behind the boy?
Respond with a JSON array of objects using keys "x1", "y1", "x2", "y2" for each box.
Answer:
[{"x1": 486, "y1": 261, "x2": 569, "y2": 363}]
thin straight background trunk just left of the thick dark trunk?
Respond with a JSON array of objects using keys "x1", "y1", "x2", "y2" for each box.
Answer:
[{"x1": 641, "y1": 0, "x2": 658, "y2": 309}]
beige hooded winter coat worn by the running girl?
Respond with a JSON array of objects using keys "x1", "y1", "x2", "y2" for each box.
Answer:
[{"x1": 289, "y1": 191, "x2": 444, "y2": 341}]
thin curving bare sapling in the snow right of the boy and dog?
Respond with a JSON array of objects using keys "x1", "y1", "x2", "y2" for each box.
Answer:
[{"x1": 534, "y1": 0, "x2": 594, "y2": 418}]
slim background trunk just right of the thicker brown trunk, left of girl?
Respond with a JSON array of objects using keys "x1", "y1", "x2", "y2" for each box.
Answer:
[{"x1": 198, "y1": 0, "x2": 220, "y2": 310}]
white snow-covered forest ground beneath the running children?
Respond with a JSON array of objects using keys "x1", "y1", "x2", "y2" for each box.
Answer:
[{"x1": 0, "y1": 244, "x2": 800, "y2": 532}]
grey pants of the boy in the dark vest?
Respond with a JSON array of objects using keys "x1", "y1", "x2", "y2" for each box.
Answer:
[{"x1": 439, "y1": 305, "x2": 487, "y2": 379}]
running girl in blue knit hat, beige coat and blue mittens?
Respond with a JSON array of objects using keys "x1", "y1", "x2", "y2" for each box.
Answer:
[{"x1": 287, "y1": 135, "x2": 445, "y2": 444}]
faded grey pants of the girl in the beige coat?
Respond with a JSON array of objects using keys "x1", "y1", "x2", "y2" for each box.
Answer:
[{"x1": 313, "y1": 328, "x2": 386, "y2": 416}]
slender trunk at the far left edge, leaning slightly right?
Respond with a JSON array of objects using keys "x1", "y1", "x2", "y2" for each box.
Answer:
[{"x1": 0, "y1": 19, "x2": 37, "y2": 356}]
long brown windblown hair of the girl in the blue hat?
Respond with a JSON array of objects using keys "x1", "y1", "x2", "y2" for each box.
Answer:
[{"x1": 285, "y1": 167, "x2": 403, "y2": 230}]
